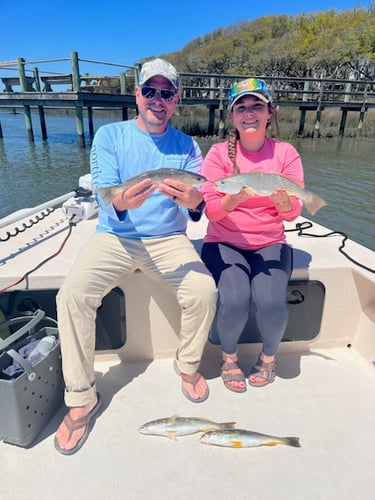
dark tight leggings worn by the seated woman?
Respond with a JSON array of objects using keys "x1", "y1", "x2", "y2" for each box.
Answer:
[{"x1": 202, "y1": 243, "x2": 293, "y2": 356}]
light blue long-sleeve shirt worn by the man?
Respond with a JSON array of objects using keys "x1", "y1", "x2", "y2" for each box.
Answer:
[{"x1": 90, "y1": 120, "x2": 202, "y2": 239}]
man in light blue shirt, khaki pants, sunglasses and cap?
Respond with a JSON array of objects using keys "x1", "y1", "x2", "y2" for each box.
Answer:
[{"x1": 55, "y1": 59, "x2": 217, "y2": 455}]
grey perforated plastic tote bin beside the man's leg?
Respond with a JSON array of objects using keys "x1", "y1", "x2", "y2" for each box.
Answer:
[{"x1": 0, "y1": 311, "x2": 64, "y2": 446}]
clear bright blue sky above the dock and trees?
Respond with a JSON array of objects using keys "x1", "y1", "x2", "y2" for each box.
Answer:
[{"x1": 0, "y1": 0, "x2": 373, "y2": 77}]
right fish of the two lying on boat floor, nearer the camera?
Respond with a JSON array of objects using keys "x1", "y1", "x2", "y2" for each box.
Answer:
[{"x1": 201, "y1": 429, "x2": 301, "y2": 448}]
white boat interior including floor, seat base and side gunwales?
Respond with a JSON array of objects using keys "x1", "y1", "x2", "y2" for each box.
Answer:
[{"x1": 0, "y1": 206, "x2": 375, "y2": 500}]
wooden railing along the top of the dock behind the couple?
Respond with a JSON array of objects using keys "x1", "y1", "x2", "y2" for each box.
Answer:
[{"x1": 0, "y1": 52, "x2": 375, "y2": 106}]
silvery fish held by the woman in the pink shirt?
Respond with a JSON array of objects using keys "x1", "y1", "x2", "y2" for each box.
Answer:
[{"x1": 214, "y1": 172, "x2": 327, "y2": 215}]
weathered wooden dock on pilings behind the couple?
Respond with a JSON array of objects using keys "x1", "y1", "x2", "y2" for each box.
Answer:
[{"x1": 0, "y1": 52, "x2": 375, "y2": 147}]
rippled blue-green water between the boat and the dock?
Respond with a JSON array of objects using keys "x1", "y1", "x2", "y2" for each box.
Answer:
[{"x1": 0, "y1": 112, "x2": 375, "y2": 250}]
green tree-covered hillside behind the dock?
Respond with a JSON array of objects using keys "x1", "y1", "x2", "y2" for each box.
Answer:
[{"x1": 154, "y1": 2, "x2": 375, "y2": 79}]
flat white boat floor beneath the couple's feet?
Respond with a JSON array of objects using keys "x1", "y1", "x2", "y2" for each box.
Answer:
[{"x1": 0, "y1": 347, "x2": 375, "y2": 500}]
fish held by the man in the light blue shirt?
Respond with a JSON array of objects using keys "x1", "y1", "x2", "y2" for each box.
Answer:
[{"x1": 96, "y1": 168, "x2": 207, "y2": 205}]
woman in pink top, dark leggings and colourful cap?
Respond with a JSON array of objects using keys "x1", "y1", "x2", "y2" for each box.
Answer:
[{"x1": 202, "y1": 78, "x2": 303, "y2": 392}]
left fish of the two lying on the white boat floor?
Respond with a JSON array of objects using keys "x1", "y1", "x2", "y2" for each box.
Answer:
[{"x1": 138, "y1": 415, "x2": 236, "y2": 441}]
